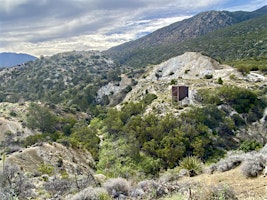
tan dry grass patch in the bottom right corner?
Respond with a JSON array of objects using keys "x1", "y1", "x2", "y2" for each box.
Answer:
[{"x1": 181, "y1": 167, "x2": 267, "y2": 200}]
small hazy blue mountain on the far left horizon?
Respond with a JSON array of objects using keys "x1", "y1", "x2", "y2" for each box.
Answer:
[{"x1": 0, "y1": 52, "x2": 36, "y2": 68}]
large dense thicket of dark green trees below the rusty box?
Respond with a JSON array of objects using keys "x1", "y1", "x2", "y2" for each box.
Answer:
[{"x1": 101, "y1": 106, "x2": 217, "y2": 172}]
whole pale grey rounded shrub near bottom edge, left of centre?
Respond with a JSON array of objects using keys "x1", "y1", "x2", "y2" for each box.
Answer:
[{"x1": 103, "y1": 178, "x2": 130, "y2": 198}]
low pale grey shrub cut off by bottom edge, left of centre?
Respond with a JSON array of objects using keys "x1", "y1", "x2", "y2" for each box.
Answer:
[{"x1": 71, "y1": 187, "x2": 111, "y2": 200}]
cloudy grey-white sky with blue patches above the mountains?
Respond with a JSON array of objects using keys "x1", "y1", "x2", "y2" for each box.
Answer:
[{"x1": 0, "y1": 0, "x2": 267, "y2": 57}]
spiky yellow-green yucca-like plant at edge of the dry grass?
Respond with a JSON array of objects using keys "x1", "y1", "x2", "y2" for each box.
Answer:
[{"x1": 179, "y1": 156, "x2": 203, "y2": 176}]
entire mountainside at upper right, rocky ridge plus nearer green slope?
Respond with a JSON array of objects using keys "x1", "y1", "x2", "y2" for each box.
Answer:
[{"x1": 105, "y1": 7, "x2": 266, "y2": 67}]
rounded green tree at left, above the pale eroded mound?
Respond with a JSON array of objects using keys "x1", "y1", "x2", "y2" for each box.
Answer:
[{"x1": 27, "y1": 103, "x2": 57, "y2": 133}]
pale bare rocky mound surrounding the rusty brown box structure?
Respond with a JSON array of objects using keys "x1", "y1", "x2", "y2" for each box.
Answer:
[{"x1": 124, "y1": 52, "x2": 267, "y2": 114}]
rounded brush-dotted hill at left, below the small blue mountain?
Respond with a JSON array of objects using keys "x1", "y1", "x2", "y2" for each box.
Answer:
[{"x1": 0, "y1": 51, "x2": 134, "y2": 110}]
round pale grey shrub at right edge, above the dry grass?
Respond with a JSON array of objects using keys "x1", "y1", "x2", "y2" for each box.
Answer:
[{"x1": 241, "y1": 157, "x2": 265, "y2": 178}]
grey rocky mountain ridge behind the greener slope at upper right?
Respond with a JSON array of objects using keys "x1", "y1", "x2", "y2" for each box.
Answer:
[{"x1": 105, "y1": 6, "x2": 267, "y2": 67}]
